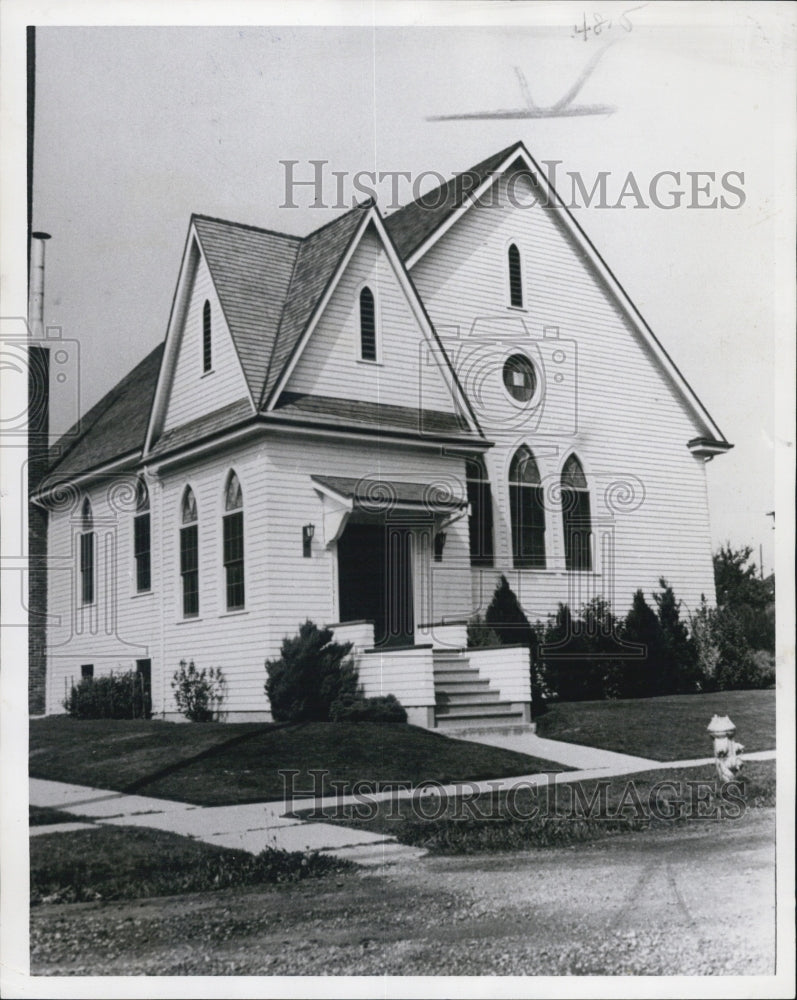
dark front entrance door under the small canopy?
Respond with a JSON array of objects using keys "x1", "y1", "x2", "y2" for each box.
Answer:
[{"x1": 338, "y1": 523, "x2": 415, "y2": 646}]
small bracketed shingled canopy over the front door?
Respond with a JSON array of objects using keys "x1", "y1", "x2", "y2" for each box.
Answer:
[{"x1": 311, "y1": 476, "x2": 468, "y2": 546}]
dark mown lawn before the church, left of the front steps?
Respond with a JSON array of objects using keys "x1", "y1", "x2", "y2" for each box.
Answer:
[{"x1": 30, "y1": 716, "x2": 568, "y2": 805}]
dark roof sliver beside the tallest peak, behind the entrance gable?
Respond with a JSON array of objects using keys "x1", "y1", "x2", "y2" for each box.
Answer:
[{"x1": 385, "y1": 142, "x2": 523, "y2": 260}]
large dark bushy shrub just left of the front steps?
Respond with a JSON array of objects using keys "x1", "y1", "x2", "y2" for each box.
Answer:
[{"x1": 265, "y1": 620, "x2": 357, "y2": 722}]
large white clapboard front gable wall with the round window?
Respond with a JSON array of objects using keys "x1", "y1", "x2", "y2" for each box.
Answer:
[{"x1": 412, "y1": 167, "x2": 714, "y2": 616}]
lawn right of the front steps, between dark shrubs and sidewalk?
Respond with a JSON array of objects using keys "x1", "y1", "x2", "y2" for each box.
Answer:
[{"x1": 536, "y1": 691, "x2": 775, "y2": 761}]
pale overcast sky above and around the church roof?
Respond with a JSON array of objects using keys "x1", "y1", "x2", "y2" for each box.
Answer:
[{"x1": 34, "y1": 4, "x2": 793, "y2": 570}]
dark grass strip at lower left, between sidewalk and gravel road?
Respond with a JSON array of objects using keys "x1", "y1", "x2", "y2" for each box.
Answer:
[{"x1": 30, "y1": 826, "x2": 351, "y2": 905}]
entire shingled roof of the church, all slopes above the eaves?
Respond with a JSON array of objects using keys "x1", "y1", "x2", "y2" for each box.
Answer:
[{"x1": 50, "y1": 143, "x2": 521, "y2": 475}]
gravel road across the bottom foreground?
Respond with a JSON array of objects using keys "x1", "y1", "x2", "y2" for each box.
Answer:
[{"x1": 31, "y1": 809, "x2": 775, "y2": 976}]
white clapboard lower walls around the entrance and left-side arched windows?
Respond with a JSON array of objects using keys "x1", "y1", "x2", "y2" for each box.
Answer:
[{"x1": 48, "y1": 435, "x2": 478, "y2": 717}]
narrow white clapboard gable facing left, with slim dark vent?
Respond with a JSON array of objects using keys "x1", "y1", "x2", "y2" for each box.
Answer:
[{"x1": 163, "y1": 255, "x2": 249, "y2": 431}]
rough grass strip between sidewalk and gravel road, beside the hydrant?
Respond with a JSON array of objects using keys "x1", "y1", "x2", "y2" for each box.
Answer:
[{"x1": 296, "y1": 761, "x2": 775, "y2": 854}]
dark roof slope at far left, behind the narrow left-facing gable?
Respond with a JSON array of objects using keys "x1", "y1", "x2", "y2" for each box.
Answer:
[{"x1": 49, "y1": 344, "x2": 163, "y2": 478}]
